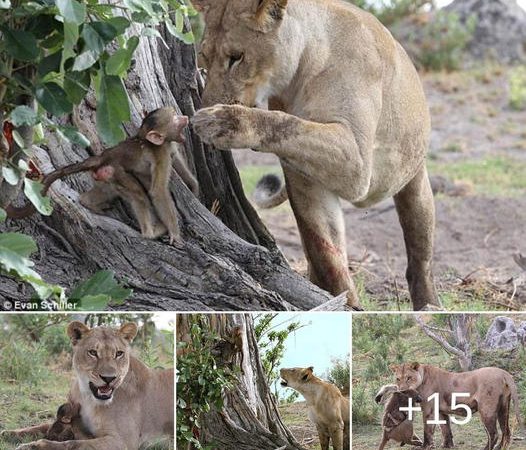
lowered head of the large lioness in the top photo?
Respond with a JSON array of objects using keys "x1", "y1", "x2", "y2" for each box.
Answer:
[{"x1": 193, "y1": 0, "x2": 290, "y2": 106}]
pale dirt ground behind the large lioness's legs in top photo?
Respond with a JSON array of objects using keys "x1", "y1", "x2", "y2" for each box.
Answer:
[{"x1": 235, "y1": 66, "x2": 526, "y2": 309}]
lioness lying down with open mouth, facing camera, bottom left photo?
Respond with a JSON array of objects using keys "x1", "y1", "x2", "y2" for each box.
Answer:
[{"x1": 3, "y1": 322, "x2": 174, "y2": 450}]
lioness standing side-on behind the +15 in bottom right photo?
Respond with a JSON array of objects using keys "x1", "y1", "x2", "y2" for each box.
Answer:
[{"x1": 391, "y1": 363, "x2": 521, "y2": 450}]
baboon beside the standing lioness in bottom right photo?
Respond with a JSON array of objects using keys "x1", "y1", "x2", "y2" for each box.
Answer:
[{"x1": 375, "y1": 385, "x2": 422, "y2": 450}]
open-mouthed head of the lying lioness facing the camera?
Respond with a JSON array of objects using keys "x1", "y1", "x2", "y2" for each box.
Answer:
[{"x1": 67, "y1": 322, "x2": 137, "y2": 402}]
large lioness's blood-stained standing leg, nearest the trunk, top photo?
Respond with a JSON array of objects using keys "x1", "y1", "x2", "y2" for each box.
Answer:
[{"x1": 284, "y1": 168, "x2": 361, "y2": 309}]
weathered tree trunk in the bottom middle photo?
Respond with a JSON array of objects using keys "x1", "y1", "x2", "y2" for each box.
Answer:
[{"x1": 176, "y1": 314, "x2": 303, "y2": 450}]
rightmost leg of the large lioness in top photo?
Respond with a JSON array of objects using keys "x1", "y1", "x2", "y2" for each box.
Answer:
[{"x1": 394, "y1": 165, "x2": 442, "y2": 310}]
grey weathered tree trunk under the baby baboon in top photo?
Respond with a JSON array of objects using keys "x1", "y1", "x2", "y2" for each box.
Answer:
[{"x1": 0, "y1": 26, "x2": 338, "y2": 310}]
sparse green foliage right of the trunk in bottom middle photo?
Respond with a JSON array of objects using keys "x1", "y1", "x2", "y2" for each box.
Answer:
[{"x1": 254, "y1": 314, "x2": 307, "y2": 403}]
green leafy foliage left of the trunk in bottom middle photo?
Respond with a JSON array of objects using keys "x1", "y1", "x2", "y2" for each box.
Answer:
[{"x1": 176, "y1": 315, "x2": 236, "y2": 449}]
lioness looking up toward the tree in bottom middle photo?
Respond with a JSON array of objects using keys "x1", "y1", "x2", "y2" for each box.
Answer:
[{"x1": 279, "y1": 367, "x2": 350, "y2": 450}]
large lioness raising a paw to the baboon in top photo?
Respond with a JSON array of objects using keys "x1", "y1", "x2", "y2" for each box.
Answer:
[{"x1": 192, "y1": 0, "x2": 440, "y2": 310}]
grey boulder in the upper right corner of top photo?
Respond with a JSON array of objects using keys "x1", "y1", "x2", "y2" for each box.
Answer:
[{"x1": 444, "y1": 0, "x2": 526, "y2": 64}]
